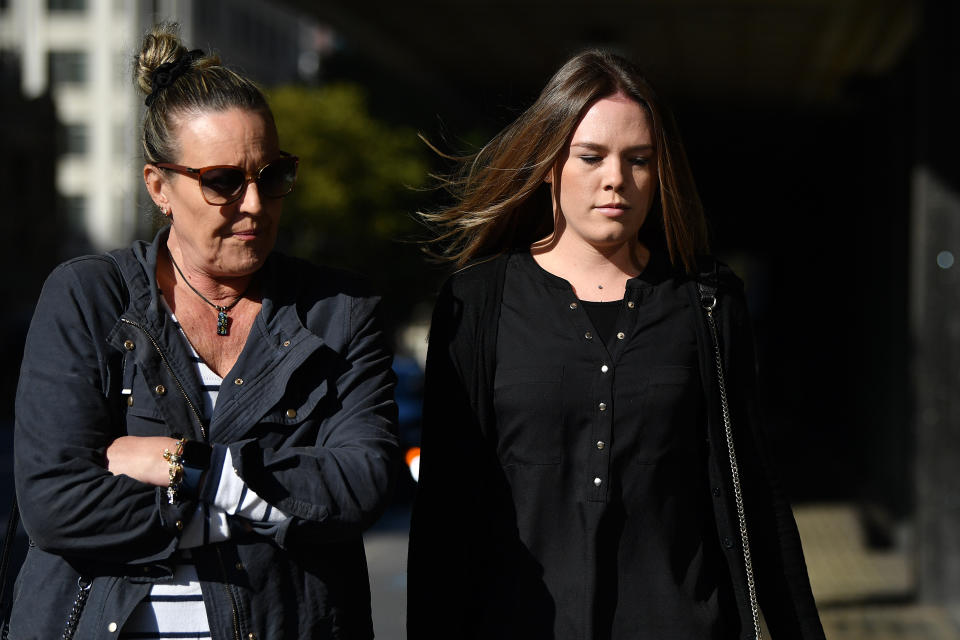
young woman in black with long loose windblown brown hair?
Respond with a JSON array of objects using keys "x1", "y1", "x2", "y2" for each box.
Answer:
[{"x1": 408, "y1": 51, "x2": 823, "y2": 640}]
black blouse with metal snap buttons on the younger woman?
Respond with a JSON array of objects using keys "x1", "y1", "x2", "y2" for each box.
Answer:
[{"x1": 494, "y1": 252, "x2": 735, "y2": 639}]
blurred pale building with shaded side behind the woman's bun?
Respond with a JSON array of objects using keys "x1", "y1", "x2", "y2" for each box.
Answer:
[{"x1": 0, "y1": 0, "x2": 331, "y2": 253}]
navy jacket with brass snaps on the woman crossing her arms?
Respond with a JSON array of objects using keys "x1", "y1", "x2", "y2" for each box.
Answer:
[{"x1": 10, "y1": 230, "x2": 399, "y2": 640}]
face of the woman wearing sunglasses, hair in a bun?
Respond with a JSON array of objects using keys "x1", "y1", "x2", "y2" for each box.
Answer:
[{"x1": 144, "y1": 109, "x2": 283, "y2": 278}]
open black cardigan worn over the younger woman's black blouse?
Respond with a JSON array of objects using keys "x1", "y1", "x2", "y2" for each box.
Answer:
[{"x1": 407, "y1": 256, "x2": 823, "y2": 640}]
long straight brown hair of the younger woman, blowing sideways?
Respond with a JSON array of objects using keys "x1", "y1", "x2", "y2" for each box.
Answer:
[{"x1": 420, "y1": 50, "x2": 708, "y2": 272}]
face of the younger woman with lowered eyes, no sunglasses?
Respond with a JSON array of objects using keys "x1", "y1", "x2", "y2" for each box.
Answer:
[{"x1": 550, "y1": 94, "x2": 658, "y2": 249}]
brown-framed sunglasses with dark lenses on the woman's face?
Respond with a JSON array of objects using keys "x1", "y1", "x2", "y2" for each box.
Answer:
[{"x1": 153, "y1": 151, "x2": 300, "y2": 206}]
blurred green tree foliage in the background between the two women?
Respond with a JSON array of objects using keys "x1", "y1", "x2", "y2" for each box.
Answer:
[{"x1": 269, "y1": 84, "x2": 435, "y2": 330}]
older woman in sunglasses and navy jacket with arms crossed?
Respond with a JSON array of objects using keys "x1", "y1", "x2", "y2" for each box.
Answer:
[{"x1": 11, "y1": 27, "x2": 397, "y2": 640}]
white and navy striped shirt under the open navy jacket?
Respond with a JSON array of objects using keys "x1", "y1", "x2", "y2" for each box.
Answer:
[{"x1": 119, "y1": 308, "x2": 289, "y2": 640}]
